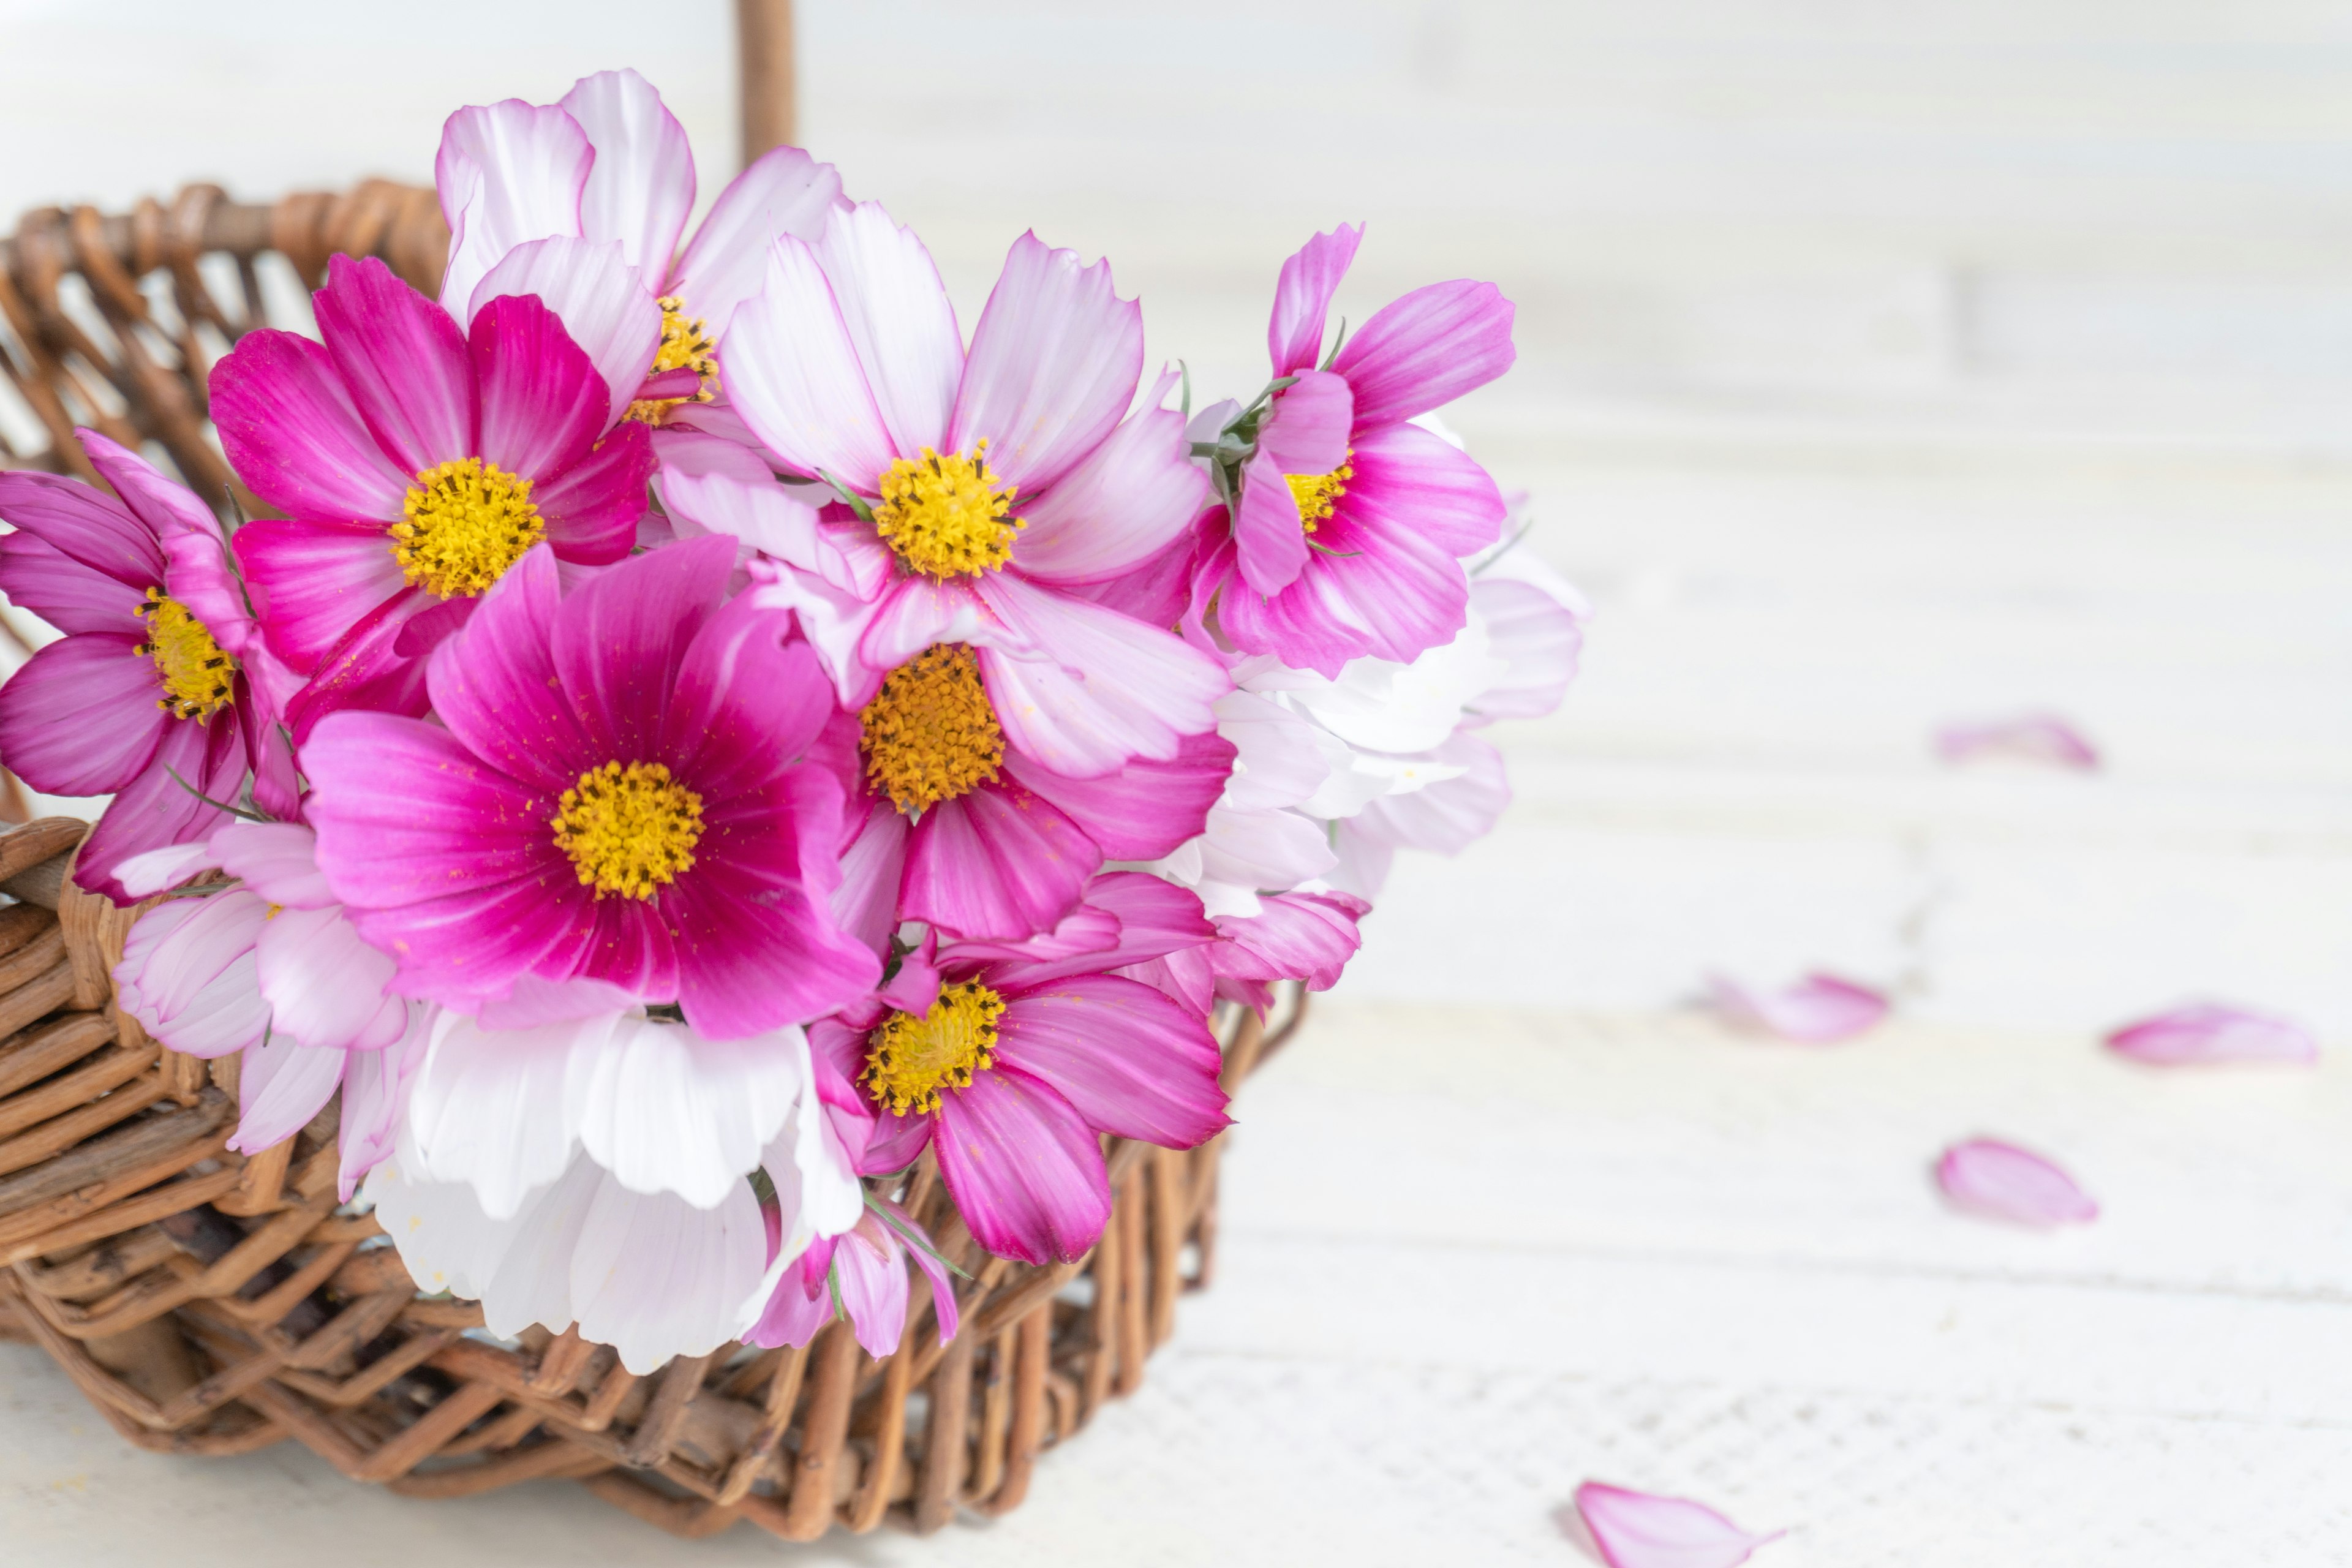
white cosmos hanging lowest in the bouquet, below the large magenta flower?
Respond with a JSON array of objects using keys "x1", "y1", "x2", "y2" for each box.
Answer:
[{"x1": 367, "y1": 982, "x2": 863, "y2": 1373}]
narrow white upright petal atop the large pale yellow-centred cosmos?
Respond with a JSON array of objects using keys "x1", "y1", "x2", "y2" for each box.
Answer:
[{"x1": 816, "y1": 202, "x2": 964, "y2": 456}]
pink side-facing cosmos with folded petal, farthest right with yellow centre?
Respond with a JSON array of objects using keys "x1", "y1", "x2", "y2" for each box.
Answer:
[{"x1": 1202, "y1": 225, "x2": 1515, "y2": 677}]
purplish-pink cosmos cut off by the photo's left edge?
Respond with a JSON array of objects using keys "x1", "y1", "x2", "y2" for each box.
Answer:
[{"x1": 0, "y1": 430, "x2": 294, "y2": 903}]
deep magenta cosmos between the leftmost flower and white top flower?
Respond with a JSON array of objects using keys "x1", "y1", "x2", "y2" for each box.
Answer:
[{"x1": 212, "y1": 256, "x2": 654, "y2": 741}]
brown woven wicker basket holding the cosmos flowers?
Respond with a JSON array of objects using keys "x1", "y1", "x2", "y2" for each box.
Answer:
[{"x1": 0, "y1": 181, "x2": 1303, "y2": 1540}]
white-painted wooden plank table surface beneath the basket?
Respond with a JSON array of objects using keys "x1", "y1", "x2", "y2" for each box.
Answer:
[{"x1": 0, "y1": 0, "x2": 2352, "y2": 1568}]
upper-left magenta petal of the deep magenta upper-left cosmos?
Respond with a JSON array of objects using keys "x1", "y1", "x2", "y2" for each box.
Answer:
[{"x1": 212, "y1": 326, "x2": 412, "y2": 522}]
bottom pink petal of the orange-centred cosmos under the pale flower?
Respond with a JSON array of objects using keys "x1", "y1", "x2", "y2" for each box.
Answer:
[{"x1": 899, "y1": 780, "x2": 1103, "y2": 936}]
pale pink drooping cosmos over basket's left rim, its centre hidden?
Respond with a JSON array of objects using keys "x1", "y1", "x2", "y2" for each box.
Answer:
[{"x1": 113, "y1": 820, "x2": 433, "y2": 1201}]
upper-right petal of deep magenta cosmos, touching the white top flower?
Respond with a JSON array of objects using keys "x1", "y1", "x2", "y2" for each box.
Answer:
[{"x1": 470, "y1": 294, "x2": 611, "y2": 480}]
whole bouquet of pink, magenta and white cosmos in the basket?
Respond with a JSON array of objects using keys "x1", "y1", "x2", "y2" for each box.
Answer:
[{"x1": 0, "y1": 70, "x2": 1583, "y2": 1371}]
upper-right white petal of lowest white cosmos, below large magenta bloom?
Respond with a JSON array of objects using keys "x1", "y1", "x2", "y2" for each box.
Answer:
[{"x1": 571, "y1": 1018, "x2": 809, "y2": 1208}]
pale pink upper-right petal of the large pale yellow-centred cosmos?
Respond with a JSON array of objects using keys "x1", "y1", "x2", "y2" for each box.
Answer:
[{"x1": 948, "y1": 233, "x2": 1143, "y2": 491}]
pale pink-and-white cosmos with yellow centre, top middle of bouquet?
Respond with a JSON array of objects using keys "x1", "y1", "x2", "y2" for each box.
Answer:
[{"x1": 706, "y1": 202, "x2": 1230, "y2": 778}]
